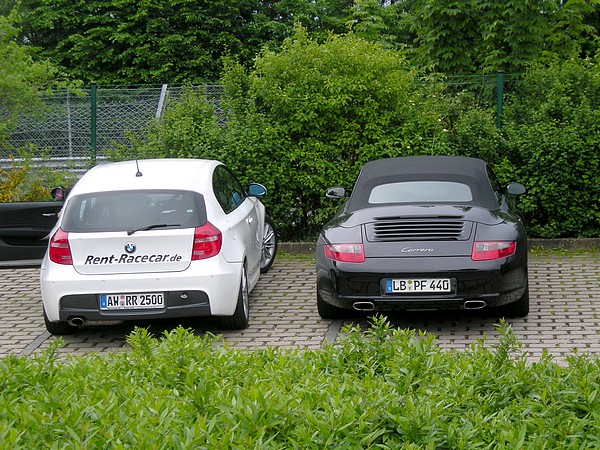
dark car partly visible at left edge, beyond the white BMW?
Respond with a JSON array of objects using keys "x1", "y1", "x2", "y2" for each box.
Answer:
[{"x1": 0, "y1": 202, "x2": 63, "y2": 267}]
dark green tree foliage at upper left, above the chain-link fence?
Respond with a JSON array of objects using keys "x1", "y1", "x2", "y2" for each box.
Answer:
[{"x1": 9, "y1": 0, "x2": 290, "y2": 83}]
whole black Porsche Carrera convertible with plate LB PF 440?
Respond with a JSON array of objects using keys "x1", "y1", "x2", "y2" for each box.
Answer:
[{"x1": 316, "y1": 156, "x2": 529, "y2": 319}]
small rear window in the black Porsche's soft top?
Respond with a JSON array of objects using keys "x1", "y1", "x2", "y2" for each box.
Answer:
[{"x1": 369, "y1": 181, "x2": 473, "y2": 204}]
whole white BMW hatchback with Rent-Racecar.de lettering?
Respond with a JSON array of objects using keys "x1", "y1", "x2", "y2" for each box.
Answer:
[{"x1": 40, "y1": 159, "x2": 277, "y2": 335}]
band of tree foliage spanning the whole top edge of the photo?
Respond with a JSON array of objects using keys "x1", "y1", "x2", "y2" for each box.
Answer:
[{"x1": 0, "y1": 0, "x2": 600, "y2": 84}]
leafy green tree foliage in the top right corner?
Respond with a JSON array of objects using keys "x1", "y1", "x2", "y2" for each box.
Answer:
[{"x1": 402, "y1": 0, "x2": 599, "y2": 74}]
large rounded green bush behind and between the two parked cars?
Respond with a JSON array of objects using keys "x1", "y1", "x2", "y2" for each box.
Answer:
[{"x1": 126, "y1": 28, "x2": 446, "y2": 239}]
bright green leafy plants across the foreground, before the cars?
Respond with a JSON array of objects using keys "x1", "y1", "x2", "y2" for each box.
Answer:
[{"x1": 0, "y1": 318, "x2": 600, "y2": 449}]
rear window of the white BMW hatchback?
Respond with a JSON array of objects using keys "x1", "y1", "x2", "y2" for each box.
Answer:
[{"x1": 61, "y1": 191, "x2": 206, "y2": 232}]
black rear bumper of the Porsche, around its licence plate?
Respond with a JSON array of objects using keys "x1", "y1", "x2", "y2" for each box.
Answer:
[{"x1": 317, "y1": 253, "x2": 528, "y2": 311}]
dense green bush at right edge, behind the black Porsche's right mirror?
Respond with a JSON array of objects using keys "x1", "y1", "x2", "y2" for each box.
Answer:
[{"x1": 503, "y1": 60, "x2": 600, "y2": 237}]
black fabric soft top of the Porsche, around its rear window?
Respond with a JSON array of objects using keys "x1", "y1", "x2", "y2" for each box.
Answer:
[{"x1": 347, "y1": 156, "x2": 498, "y2": 211}]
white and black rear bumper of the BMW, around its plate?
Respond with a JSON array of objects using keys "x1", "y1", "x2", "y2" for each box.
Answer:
[{"x1": 40, "y1": 255, "x2": 242, "y2": 322}]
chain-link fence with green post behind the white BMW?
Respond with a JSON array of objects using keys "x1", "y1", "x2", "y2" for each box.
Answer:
[{"x1": 0, "y1": 85, "x2": 222, "y2": 167}]
